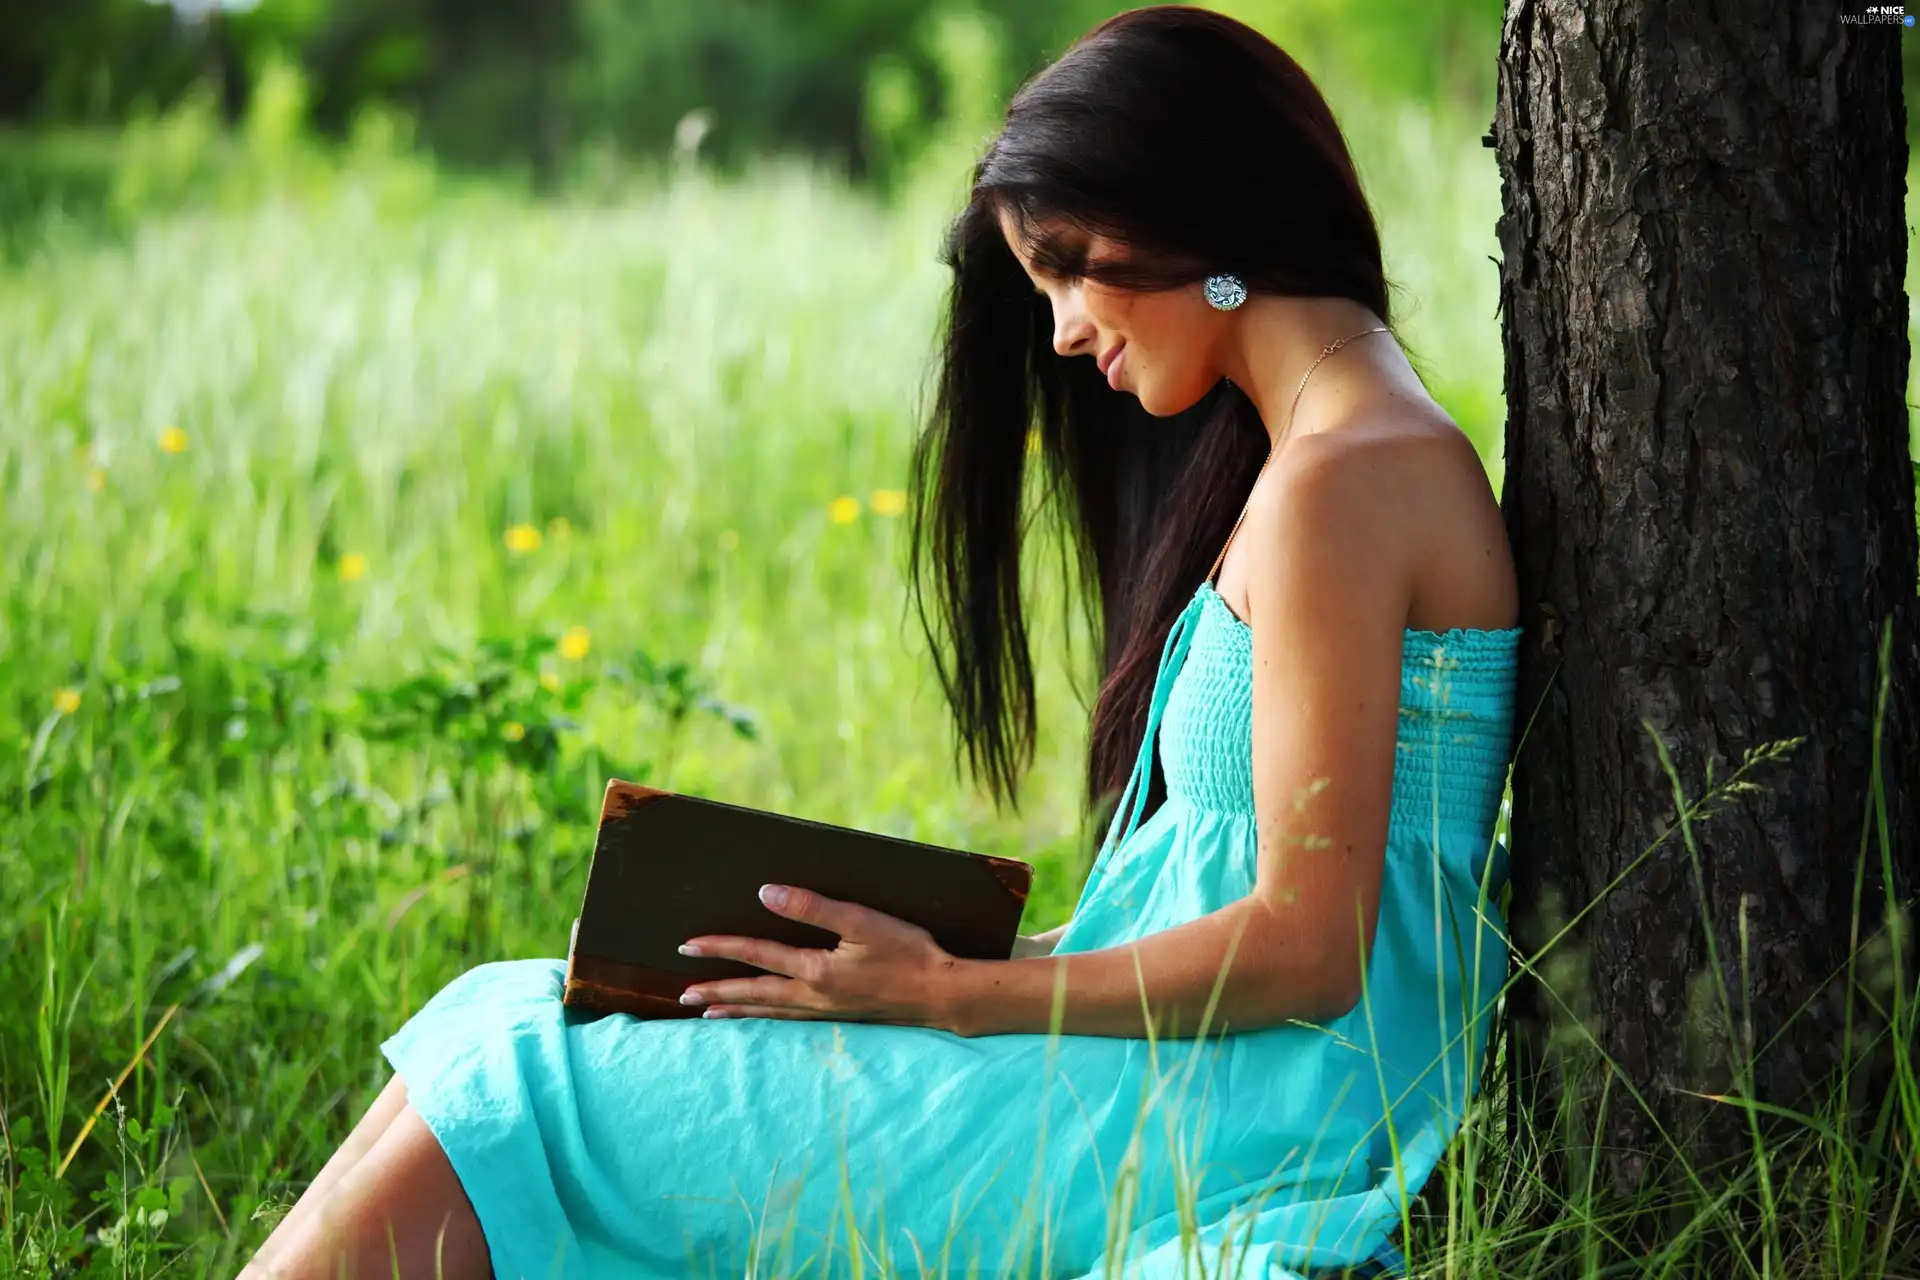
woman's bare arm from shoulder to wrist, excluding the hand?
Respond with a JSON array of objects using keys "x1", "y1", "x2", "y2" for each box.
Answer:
[{"x1": 927, "y1": 438, "x2": 1411, "y2": 1038}]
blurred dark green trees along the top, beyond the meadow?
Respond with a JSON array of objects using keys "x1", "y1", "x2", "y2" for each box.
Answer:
[{"x1": 11, "y1": 0, "x2": 1501, "y2": 182}]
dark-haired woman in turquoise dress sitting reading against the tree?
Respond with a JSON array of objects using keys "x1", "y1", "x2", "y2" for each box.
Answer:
[{"x1": 246, "y1": 6, "x2": 1519, "y2": 1278}]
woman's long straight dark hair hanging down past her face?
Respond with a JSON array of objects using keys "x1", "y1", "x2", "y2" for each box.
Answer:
[{"x1": 908, "y1": 4, "x2": 1392, "y2": 855}]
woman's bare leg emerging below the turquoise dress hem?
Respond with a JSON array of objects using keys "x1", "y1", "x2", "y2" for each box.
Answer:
[{"x1": 240, "y1": 1107, "x2": 493, "y2": 1280}]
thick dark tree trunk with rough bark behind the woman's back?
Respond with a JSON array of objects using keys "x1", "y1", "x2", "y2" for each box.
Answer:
[{"x1": 1492, "y1": 0, "x2": 1920, "y2": 1220}]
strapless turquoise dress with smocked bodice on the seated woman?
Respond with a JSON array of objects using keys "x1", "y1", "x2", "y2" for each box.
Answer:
[{"x1": 384, "y1": 580, "x2": 1519, "y2": 1280}]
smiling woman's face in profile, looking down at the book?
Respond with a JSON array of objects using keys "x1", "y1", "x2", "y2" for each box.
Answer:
[{"x1": 1000, "y1": 211, "x2": 1229, "y2": 418}]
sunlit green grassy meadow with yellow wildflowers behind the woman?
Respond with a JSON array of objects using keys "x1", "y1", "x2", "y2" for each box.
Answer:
[{"x1": 0, "y1": 75, "x2": 1920, "y2": 1276}]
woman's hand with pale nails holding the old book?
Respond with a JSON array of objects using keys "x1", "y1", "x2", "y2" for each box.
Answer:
[{"x1": 680, "y1": 885, "x2": 958, "y2": 1027}]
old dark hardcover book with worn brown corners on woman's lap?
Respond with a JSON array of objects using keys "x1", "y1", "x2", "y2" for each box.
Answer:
[{"x1": 561, "y1": 779, "x2": 1033, "y2": 1017}]
